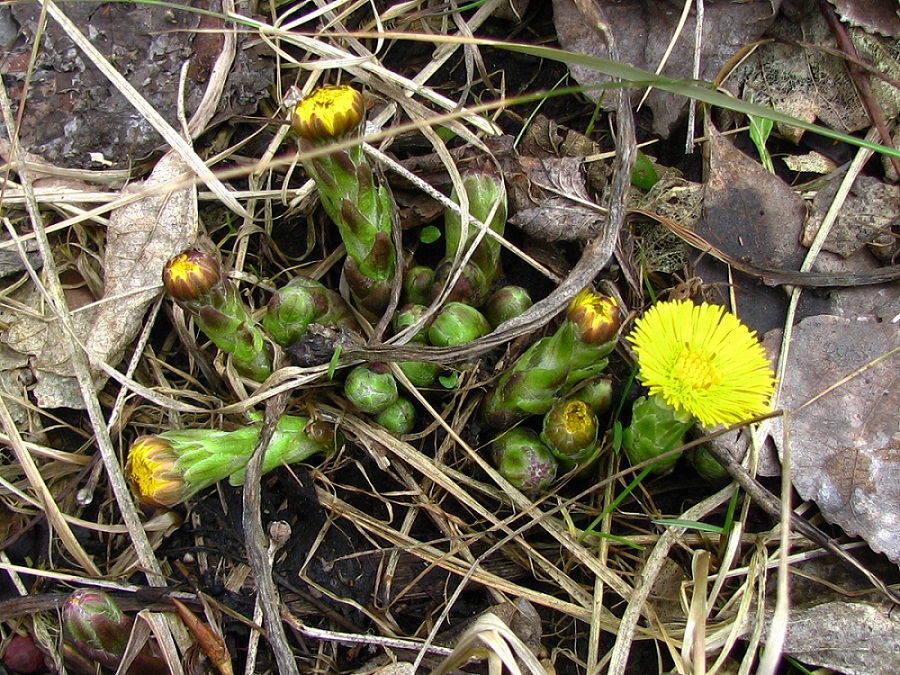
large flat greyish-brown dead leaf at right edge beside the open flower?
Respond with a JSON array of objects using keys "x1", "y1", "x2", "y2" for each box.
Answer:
[{"x1": 766, "y1": 316, "x2": 900, "y2": 563}]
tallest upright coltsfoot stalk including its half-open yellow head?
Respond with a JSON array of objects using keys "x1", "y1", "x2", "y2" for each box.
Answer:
[{"x1": 294, "y1": 87, "x2": 397, "y2": 317}]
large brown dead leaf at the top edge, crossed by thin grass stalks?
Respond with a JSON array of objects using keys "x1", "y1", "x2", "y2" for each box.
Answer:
[{"x1": 553, "y1": 0, "x2": 781, "y2": 137}]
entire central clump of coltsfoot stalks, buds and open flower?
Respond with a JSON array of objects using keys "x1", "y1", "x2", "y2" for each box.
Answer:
[{"x1": 148, "y1": 86, "x2": 773, "y2": 506}]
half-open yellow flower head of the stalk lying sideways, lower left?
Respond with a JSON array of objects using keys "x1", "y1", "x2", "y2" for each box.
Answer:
[{"x1": 125, "y1": 436, "x2": 188, "y2": 506}]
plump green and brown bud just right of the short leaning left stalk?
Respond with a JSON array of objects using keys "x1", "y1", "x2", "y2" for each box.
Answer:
[{"x1": 262, "y1": 277, "x2": 359, "y2": 348}]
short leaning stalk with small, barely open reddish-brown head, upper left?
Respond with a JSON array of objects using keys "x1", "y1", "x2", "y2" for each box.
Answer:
[{"x1": 163, "y1": 251, "x2": 272, "y2": 382}]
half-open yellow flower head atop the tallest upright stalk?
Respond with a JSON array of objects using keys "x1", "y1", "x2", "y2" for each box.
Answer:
[{"x1": 291, "y1": 85, "x2": 363, "y2": 141}]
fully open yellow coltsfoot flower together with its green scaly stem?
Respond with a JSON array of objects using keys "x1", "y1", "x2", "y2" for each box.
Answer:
[{"x1": 622, "y1": 301, "x2": 775, "y2": 473}]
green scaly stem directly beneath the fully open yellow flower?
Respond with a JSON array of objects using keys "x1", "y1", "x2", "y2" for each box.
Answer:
[{"x1": 622, "y1": 396, "x2": 694, "y2": 474}]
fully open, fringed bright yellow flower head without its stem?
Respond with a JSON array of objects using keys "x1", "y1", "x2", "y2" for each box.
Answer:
[{"x1": 628, "y1": 301, "x2": 775, "y2": 427}]
